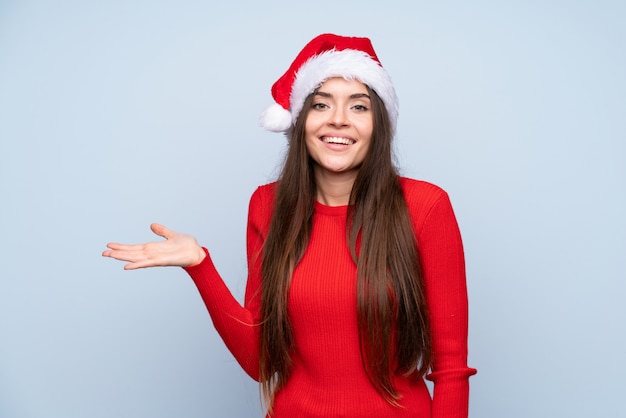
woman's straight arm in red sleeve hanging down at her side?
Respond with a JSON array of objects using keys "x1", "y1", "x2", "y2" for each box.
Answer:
[{"x1": 418, "y1": 192, "x2": 476, "y2": 418}]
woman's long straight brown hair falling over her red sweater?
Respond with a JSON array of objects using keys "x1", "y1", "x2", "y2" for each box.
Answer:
[{"x1": 260, "y1": 81, "x2": 431, "y2": 411}]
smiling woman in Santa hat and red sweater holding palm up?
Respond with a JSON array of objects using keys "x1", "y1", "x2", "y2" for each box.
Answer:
[{"x1": 103, "y1": 34, "x2": 476, "y2": 418}]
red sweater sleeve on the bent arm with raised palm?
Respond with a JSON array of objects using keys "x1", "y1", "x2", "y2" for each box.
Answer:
[{"x1": 180, "y1": 186, "x2": 272, "y2": 380}]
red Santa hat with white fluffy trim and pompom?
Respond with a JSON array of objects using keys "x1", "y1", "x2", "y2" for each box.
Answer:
[{"x1": 260, "y1": 34, "x2": 398, "y2": 136}]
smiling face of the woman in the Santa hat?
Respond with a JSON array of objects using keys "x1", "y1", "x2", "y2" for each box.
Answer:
[{"x1": 305, "y1": 78, "x2": 374, "y2": 177}]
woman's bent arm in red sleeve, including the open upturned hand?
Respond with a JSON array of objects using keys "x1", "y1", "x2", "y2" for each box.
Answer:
[{"x1": 102, "y1": 190, "x2": 271, "y2": 380}]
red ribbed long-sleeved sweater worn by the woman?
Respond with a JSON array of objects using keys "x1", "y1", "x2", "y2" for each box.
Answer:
[{"x1": 186, "y1": 178, "x2": 476, "y2": 418}]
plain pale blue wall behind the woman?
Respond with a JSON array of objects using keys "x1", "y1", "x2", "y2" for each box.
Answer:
[{"x1": 0, "y1": 0, "x2": 626, "y2": 418}]
